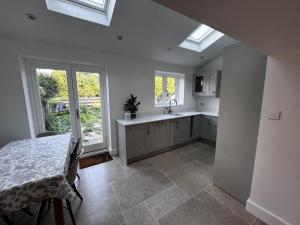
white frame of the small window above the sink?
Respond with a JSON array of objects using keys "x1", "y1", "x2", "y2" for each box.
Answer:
[{"x1": 153, "y1": 71, "x2": 185, "y2": 107}]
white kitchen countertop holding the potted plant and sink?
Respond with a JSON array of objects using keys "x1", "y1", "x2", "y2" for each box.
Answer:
[{"x1": 117, "y1": 111, "x2": 219, "y2": 126}]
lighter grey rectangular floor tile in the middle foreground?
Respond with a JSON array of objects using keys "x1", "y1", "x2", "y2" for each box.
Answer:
[{"x1": 145, "y1": 185, "x2": 190, "y2": 220}]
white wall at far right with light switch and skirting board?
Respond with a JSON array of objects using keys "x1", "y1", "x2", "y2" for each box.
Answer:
[{"x1": 247, "y1": 49, "x2": 300, "y2": 225}]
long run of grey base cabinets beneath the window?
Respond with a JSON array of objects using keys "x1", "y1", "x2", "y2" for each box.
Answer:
[{"x1": 118, "y1": 117, "x2": 192, "y2": 163}]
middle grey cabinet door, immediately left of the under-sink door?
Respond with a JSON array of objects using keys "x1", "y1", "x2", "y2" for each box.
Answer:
[{"x1": 148, "y1": 120, "x2": 170, "y2": 152}]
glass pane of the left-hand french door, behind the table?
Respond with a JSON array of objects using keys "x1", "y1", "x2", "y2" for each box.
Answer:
[{"x1": 36, "y1": 68, "x2": 71, "y2": 134}]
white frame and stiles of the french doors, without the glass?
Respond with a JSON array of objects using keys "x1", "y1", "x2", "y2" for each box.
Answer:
[{"x1": 24, "y1": 58, "x2": 108, "y2": 152}]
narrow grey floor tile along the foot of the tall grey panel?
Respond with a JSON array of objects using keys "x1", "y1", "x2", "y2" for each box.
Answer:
[{"x1": 205, "y1": 185, "x2": 256, "y2": 224}]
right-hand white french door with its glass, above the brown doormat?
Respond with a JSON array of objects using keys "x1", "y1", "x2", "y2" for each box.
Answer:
[{"x1": 72, "y1": 66, "x2": 106, "y2": 152}]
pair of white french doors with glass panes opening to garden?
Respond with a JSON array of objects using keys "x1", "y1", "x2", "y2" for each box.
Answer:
[{"x1": 26, "y1": 60, "x2": 107, "y2": 152}]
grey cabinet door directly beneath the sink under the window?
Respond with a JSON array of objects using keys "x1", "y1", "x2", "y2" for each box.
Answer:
[{"x1": 174, "y1": 117, "x2": 191, "y2": 144}]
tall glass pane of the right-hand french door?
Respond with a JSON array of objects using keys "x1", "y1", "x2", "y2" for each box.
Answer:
[{"x1": 76, "y1": 72, "x2": 103, "y2": 146}]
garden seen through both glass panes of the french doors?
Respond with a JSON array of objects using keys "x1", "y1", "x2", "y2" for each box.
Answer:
[{"x1": 37, "y1": 69, "x2": 103, "y2": 145}]
